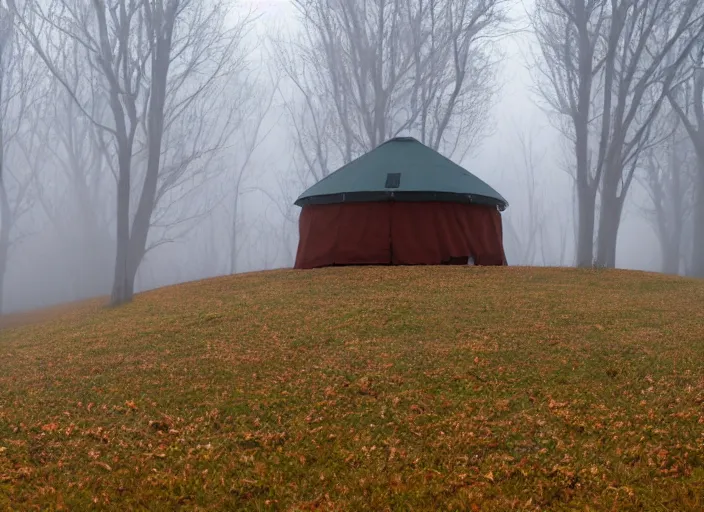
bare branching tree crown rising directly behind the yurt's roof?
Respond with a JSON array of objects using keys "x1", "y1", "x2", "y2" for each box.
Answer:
[{"x1": 277, "y1": 0, "x2": 507, "y2": 186}]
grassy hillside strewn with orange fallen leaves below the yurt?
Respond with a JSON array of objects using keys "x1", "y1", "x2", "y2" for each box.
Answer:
[{"x1": 0, "y1": 267, "x2": 704, "y2": 511}]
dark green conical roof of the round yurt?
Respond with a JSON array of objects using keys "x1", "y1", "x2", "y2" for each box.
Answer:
[{"x1": 295, "y1": 137, "x2": 508, "y2": 210}]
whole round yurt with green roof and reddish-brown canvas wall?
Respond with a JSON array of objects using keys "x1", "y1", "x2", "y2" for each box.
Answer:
[{"x1": 295, "y1": 137, "x2": 508, "y2": 269}]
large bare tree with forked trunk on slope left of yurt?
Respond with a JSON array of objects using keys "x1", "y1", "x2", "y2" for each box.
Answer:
[{"x1": 10, "y1": 0, "x2": 258, "y2": 305}]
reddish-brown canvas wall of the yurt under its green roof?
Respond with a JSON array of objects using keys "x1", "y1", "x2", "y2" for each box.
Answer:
[{"x1": 295, "y1": 202, "x2": 506, "y2": 268}]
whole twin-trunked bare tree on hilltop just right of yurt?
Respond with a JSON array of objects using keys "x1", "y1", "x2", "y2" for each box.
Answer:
[{"x1": 533, "y1": 0, "x2": 704, "y2": 267}]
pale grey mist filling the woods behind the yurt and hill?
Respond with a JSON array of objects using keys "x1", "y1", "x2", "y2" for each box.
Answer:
[{"x1": 0, "y1": 0, "x2": 704, "y2": 313}]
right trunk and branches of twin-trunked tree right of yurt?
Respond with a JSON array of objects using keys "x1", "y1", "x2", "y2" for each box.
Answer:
[{"x1": 596, "y1": 0, "x2": 704, "y2": 267}]
